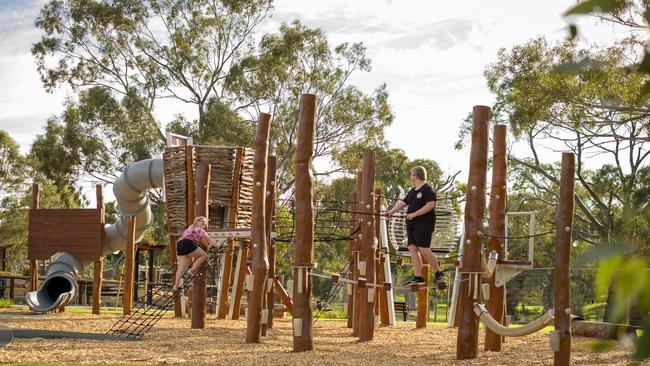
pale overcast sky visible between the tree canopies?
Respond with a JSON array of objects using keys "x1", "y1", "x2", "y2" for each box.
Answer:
[{"x1": 0, "y1": 0, "x2": 620, "y2": 194}]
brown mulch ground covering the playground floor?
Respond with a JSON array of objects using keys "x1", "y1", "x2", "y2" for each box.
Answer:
[{"x1": 0, "y1": 313, "x2": 630, "y2": 366}]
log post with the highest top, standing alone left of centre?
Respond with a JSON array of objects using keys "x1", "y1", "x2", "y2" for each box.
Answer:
[{"x1": 292, "y1": 94, "x2": 316, "y2": 352}]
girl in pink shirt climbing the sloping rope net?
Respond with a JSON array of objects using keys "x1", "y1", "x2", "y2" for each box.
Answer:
[{"x1": 172, "y1": 216, "x2": 214, "y2": 292}]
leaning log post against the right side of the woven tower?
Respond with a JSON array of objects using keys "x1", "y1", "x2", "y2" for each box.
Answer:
[{"x1": 217, "y1": 147, "x2": 244, "y2": 319}]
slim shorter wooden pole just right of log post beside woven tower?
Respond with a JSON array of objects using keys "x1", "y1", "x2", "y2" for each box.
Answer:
[{"x1": 262, "y1": 156, "x2": 277, "y2": 336}]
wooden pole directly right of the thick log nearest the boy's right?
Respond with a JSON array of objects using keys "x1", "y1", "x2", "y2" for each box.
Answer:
[{"x1": 485, "y1": 125, "x2": 508, "y2": 351}]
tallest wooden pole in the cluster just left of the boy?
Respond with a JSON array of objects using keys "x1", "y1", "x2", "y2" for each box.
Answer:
[{"x1": 359, "y1": 151, "x2": 376, "y2": 342}]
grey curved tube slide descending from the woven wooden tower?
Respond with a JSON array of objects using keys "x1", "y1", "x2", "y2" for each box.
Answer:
[{"x1": 25, "y1": 159, "x2": 163, "y2": 311}]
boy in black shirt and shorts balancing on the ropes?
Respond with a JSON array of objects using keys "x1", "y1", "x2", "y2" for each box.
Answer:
[{"x1": 386, "y1": 166, "x2": 445, "y2": 283}]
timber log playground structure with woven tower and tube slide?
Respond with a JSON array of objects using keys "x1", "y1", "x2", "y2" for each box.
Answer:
[{"x1": 13, "y1": 99, "x2": 592, "y2": 364}]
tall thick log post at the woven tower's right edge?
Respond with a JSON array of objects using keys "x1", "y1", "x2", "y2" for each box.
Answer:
[{"x1": 246, "y1": 113, "x2": 271, "y2": 343}]
